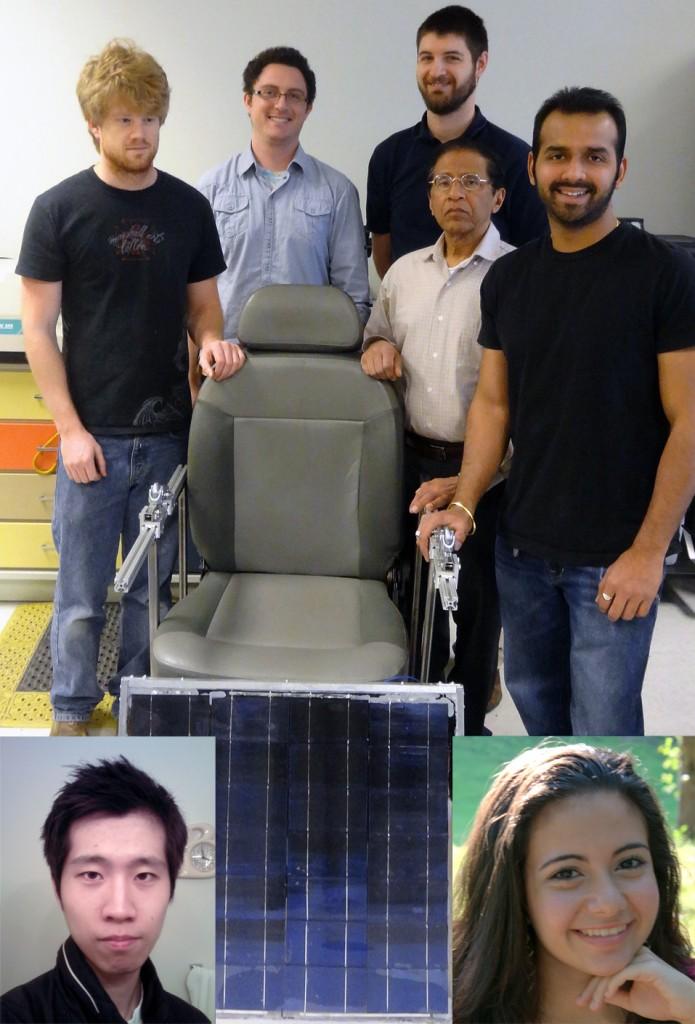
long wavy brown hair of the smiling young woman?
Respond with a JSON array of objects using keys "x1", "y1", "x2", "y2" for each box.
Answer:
[{"x1": 453, "y1": 743, "x2": 691, "y2": 1024}]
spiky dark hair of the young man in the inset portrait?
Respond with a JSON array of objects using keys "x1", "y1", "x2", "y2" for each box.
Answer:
[{"x1": 41, "y1": 757, "x2": 188, "y2": 898}]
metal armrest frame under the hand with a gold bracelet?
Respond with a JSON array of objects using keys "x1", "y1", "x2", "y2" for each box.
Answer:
[{"x1": 410, "y1": 527, "x2": 460, "y2": 683}]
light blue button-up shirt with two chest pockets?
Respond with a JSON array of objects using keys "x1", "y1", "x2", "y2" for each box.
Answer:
[{"x1": 198, "y1": 145, "x2": 370, "y2": 338}]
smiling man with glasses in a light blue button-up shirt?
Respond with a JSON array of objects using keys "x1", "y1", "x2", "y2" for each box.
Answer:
[{"x1": 199, "y1": 46, "x2": 368, "y2": 350}]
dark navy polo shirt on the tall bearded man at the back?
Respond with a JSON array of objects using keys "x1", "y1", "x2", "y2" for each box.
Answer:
[{"x1": 366, "y1": 106, "x2": 548, "y2": 260}]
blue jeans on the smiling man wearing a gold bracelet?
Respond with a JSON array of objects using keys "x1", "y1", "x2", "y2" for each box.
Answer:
[{"x1": 495, "y1": 537, "x2": 658, "y2": 736}]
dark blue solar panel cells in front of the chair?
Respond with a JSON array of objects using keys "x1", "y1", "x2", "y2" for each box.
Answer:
[{"x1": 129, "y1": 691, "x2": 449, "y2": 1017}]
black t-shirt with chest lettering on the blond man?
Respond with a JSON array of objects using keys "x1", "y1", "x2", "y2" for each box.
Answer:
[{"x1": 16, "y1": 169, "x2": 225, "y2": 434}]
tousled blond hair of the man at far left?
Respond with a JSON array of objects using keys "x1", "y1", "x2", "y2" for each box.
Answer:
[{"x1": 77, "y1": 39, "x2": 170, "y2": 150}]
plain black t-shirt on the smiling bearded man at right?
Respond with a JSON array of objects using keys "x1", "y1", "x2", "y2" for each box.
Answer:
[{"x1": 479, "y1": 224, "x2": 695, "y2": 566}]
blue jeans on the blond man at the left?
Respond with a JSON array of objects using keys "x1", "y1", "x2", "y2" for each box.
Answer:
[{"x1": 51, "y1": 434, "x2": 186, "y2": 722}]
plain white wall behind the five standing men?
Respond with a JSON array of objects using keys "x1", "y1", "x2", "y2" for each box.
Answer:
[{"x1": 0, "y1": 0, "x2": 695, "y2": 257}]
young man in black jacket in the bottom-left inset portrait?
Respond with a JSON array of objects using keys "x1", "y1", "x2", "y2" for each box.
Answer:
[{"x1": 0, "y1": 757, "x2": 208, "y2": 1024}]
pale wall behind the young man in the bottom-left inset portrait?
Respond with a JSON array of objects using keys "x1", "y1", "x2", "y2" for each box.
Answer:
[{"x1": 0, "y1": 736, "x2": 215, "y2": 998}]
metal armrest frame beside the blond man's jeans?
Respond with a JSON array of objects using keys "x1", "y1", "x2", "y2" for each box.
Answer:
[{"x1": 114, "y1": 466, "x2": 188, "y2": 642}]
